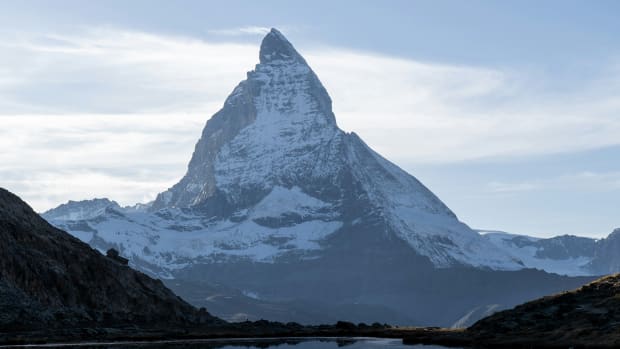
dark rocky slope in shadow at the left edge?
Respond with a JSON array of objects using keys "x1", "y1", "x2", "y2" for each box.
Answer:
[{"x1": 0, "y1": 188, "x2": 220, "y2": 332}]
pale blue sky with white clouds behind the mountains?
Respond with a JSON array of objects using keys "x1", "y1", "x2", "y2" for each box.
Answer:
[{"x1": 0, "y1": 0, "x2": 620, "y2": 237}]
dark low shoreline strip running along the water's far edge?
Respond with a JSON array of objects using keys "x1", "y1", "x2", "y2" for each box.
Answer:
[{"x1": 0, "y1": 323, "x2": 618, "y2": 349}]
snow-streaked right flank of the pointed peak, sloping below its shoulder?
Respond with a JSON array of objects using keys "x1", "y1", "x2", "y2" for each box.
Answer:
[{"x1": 351, "y1": 135, "x2": 522, "y2": 270}]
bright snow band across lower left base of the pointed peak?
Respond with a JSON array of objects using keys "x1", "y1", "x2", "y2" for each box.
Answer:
[{"x1": 50, "y1": 188, "x2": 342, "y2": 277}]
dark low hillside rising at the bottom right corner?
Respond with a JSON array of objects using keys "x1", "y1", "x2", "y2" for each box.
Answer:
[{"x1": 467, "y1": 274, "x2": 620, "y2": 348}]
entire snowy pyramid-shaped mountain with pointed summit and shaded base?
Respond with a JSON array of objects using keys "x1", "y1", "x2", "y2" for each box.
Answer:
[{"x1": 44, "y1": 29, "x2": 585, "y2": 325}]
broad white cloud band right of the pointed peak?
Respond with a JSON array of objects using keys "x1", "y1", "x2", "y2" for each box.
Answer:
[{"x1": 311, "y1": 52, "x2": 620, "y2": 163}]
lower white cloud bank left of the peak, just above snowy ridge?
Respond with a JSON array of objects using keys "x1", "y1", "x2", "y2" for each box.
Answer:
[{"x1": 0, "y1": 113, "x2": 204, "y2": 211}]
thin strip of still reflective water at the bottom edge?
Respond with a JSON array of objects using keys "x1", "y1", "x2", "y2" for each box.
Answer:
[{"x1": 17, "y1": 338, "x2": 458, "y2": 349}]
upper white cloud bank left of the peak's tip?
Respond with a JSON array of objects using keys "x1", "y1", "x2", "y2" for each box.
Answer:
[{"x1": 0, "y1": 29, "x2": 258, "y2": 114}]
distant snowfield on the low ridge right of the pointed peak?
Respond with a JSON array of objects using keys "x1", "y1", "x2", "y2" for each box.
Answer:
[{"x1": 481, "y1": 231, "x2": 595, "y2": 276}]
